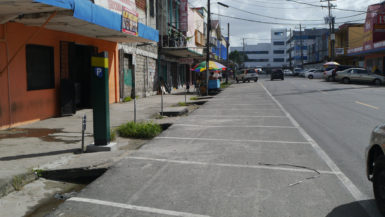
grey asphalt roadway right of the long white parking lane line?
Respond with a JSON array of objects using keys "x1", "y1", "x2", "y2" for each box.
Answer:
[{"x1": 264, "y1": 78, "x2": 385, "y2": 201}]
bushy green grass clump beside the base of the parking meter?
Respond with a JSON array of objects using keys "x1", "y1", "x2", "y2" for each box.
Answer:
[{"x1": 118, "y1": 121, "x2": 162, "y2": 139}]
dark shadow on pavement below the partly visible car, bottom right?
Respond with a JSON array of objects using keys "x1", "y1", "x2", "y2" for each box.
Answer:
[{"x1": 327, "y1": 200, "x2": 381, "y2": 217}]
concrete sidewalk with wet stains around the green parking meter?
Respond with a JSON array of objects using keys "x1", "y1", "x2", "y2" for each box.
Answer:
[{"x1": 0, "y1": 90, "x2": 198, "y2": 197}]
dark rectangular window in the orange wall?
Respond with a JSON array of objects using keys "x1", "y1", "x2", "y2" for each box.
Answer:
[{"x1": 26, "y1": 44, "x2": 55, "y2": 90}]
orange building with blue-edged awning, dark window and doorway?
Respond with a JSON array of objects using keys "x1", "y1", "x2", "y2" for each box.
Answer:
[{"x1": 0, "y1": 0, "x2": 158, "y2": 128}]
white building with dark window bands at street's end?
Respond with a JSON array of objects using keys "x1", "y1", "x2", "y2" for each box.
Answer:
[{"x1": 231, "y1": 29, "x2": 287, "y2": 68}]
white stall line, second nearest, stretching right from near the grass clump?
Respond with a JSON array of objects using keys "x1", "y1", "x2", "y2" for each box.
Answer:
[{"x1": 126, "y1": 156, "x2": 336, "y2": 175}]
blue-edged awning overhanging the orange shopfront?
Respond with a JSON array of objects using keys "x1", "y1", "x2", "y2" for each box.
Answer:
[{"x1": 0, "y1": 0, "x2": 159, "y2": 43}]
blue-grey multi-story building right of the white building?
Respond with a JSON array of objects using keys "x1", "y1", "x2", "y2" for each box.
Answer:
[{"x1": 286, "y1": 29, "x2": 329, "y2": 67}]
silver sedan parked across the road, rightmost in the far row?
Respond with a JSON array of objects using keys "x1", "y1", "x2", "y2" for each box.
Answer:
[{"x1": 335, "y1": 68, "x2": 385, "y2": 85}]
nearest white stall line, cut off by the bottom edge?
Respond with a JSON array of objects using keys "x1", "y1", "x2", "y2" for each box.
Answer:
[{"x1": 67, "y1": 197, "x2": 210, "y2": 217}]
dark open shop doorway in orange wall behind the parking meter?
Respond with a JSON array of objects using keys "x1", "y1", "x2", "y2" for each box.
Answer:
[{"x1": 60, "y1": 41, "x2": 97, "y2": 116}]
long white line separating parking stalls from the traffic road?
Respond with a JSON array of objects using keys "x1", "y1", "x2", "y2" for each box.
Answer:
[{"x1": 259, "y1": 83, "x2": 378, "y2": 216}]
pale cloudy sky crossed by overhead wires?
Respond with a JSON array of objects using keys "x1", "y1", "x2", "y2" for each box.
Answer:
[{"x1": 188, "y1": 0, "x2": 384, "y2": 47}]
